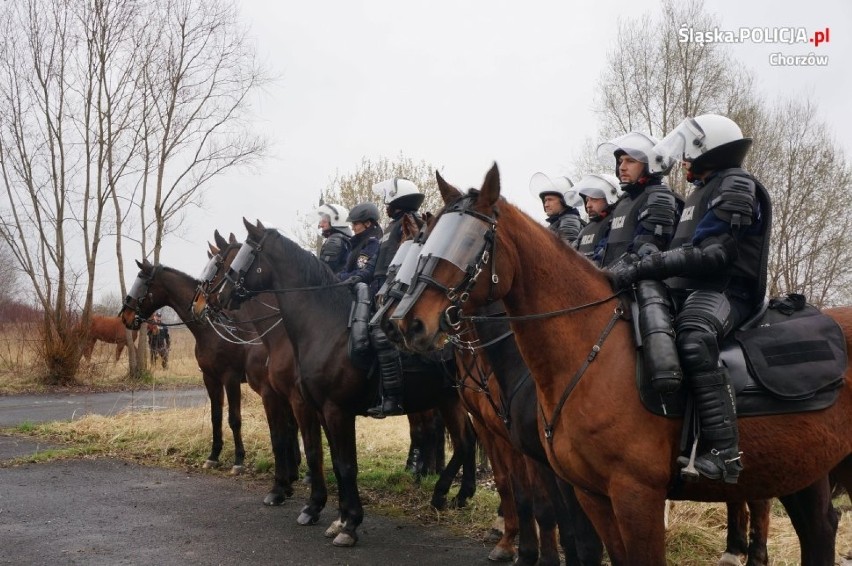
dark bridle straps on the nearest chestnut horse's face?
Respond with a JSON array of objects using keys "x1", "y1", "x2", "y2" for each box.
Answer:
[{"x1": 391, "y1": 195, "x2": 500, "y2": 333}]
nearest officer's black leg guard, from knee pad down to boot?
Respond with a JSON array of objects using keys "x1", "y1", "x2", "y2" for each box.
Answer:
[{"x1": 677, "y1": 291, "x2": 742, "y2": 483}]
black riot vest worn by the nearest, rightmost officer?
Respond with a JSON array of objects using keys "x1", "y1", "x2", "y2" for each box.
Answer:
[{"x1": 666, "y1": 168, "x2": 772, "y2": 301}]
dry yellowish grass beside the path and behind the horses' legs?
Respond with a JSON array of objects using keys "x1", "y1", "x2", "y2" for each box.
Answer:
[{"x1": 0, "y1": 329, "x2": 852, "y2": 566}]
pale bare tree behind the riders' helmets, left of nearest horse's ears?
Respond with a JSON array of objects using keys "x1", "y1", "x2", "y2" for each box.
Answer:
[{"x1": 295, "y1": 153, "x2": 443, "y2": 252}]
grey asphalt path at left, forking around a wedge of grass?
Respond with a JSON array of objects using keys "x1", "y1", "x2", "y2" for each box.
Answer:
[{"x1": 0, "y1": 391, "x2": 491, "y2": 566}]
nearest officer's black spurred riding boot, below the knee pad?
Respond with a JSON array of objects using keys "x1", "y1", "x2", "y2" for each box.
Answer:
[{"x1": 678, "y1": 368, "x2": 743, "y2": 483}]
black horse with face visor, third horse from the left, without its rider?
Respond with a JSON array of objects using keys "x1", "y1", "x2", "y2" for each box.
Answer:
[{"x1": 194, "y1": 221, "x2": 476, "y2": 546}]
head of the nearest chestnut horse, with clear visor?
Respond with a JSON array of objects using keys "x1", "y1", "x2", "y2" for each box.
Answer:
[{"x1": 389, "y1": 164, "x2": 515, "y2": 351}]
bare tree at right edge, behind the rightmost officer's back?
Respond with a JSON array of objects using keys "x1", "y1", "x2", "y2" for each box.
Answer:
[{"x1": 748, "y1": 100, "x2": 852, "y2": 306}]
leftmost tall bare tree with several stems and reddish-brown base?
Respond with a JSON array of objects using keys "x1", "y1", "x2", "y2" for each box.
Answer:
[{"x1": 0, "y1": 0, "x2": 143, "y2": 383}]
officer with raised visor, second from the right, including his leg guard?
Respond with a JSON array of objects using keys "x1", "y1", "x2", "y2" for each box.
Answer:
[{"x1": 597, "y1": 132, "x2": 683, "y2": 414}]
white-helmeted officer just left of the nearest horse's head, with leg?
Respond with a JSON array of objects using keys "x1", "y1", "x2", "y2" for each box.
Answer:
[{"x1": 367, "y1": 177, "x2": 426, "y2": 419}]
